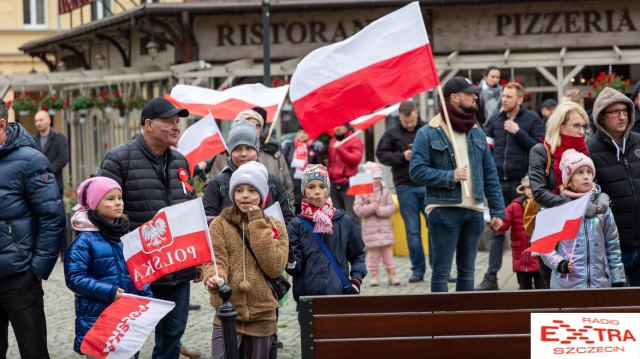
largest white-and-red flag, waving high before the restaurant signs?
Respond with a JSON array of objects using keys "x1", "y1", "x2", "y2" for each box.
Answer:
[{"x1": 289, "y1": 1, "x2": 440, "y2": 138}]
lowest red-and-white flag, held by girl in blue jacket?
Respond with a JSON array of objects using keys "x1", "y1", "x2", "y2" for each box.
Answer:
[{"x1": 80, "y1": 293, "x2": 175, "y2": 359}]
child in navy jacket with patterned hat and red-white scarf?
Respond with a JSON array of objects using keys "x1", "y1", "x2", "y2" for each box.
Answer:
[{"x1": 287, "y1": 165, "x2": 367, "y2": 318}]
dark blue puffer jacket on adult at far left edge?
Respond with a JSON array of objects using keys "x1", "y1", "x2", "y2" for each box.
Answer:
[{"x1": 0, "y1": 122, "x2": 66, "y2": 279}]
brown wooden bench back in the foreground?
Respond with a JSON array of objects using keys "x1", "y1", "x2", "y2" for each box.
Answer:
[{"x1": 300, "y1": 288, "x2": 640, "y2": 359}]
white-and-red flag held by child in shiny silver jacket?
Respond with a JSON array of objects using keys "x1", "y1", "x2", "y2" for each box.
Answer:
[{"x1": 525, "y1": 195, "x2": 591, "y2": 254}]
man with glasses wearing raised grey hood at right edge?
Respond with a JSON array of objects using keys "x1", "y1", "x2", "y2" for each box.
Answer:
[{"x1": 587, "y1": 87, "x2": 640, "y2": 287}]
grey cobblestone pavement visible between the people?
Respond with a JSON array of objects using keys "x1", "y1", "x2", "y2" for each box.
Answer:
[{"x1": 7, "y1": 250, "x2": 518, "y2": 359}]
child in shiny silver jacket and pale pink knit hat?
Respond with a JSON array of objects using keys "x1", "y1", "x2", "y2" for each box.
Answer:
[{"x1": 540, "y1": 149, "x2": 625, "y2": 289}]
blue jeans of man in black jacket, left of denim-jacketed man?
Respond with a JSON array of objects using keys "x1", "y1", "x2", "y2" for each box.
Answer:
[{"x1": 396, "y1": 185, "x2": 433, "y2": 276}]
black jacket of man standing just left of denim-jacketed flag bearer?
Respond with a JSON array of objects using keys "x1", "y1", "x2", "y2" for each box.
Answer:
[{"x1": 376, "y1": 119, "x2": 424, "y2": 187}]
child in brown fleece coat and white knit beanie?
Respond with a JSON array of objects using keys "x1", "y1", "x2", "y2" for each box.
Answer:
[{"x1": 205, "y1": 161, "x2": 288, "y2": 359}]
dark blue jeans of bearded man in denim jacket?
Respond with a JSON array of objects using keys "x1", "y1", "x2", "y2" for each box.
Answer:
[{"x1": 427, "y1": 207, "x2": 484, "y2": 292}]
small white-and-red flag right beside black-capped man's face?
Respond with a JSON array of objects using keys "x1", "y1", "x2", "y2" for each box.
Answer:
[{"x1": 178, "y1": 114, "x2": 229, "y2": 167}]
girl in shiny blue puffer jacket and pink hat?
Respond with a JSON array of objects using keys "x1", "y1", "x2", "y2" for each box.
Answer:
[{"x1": 64, "y1": 177, "x2": 152, "y2": 357}]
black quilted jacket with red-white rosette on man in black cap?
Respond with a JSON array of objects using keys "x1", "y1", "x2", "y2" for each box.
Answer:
[{"x1": 99, "y1": 135, "x2": 197, "y2": 285}]
